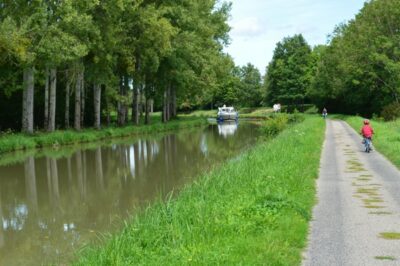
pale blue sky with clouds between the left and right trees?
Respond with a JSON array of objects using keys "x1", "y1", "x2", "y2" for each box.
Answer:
[{"x1": 226, "y1": 0, "x2": 365, "y2": 73}]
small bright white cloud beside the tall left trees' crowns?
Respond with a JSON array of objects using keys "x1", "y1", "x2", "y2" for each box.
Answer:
[{"x1": 231, "y1": 17, "x2": 265, "y2": 37}]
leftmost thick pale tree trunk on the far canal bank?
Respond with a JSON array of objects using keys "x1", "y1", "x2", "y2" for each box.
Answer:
[{"x1": 22, "y1": 67, "x2": 35, "y2": 134}]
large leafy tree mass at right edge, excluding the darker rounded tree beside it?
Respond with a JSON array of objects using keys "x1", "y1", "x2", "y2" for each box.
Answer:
[{"x1": 309, "y1": 0, "x2": 400, "y2": 116}]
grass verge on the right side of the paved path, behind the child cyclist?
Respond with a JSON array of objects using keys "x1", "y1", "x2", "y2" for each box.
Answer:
[{"x1": 343, "y1": 116, "x2": 400, "y2": 168}]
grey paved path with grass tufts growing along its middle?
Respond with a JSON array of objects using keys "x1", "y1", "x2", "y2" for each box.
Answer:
[{"x1": 303, "y1": 120, "x2": 400, "y2": 266}]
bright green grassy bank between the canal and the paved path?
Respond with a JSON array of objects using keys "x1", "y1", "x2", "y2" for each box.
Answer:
[{"x1": 75, "y1": 117, "x2": 324, "y2": 265}]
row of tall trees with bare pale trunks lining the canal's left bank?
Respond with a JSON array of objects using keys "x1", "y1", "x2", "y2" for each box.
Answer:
[{"x1": 0, "y1": 0, "x2": 260, "y2": 133}]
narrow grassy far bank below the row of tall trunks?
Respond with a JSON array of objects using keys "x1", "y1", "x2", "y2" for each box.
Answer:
[{"x1": 0, "y1": 117, "x2": 207, "y2": 154}]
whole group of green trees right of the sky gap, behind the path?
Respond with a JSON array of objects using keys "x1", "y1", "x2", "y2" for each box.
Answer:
[{"x1": 264, "y1": 0, "x2": 400, "y2": 116}]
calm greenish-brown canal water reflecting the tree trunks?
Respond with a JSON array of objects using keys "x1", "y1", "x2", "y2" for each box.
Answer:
[{"x1": 0, "y1": 123, "x2": 259, "y2": 266}]
